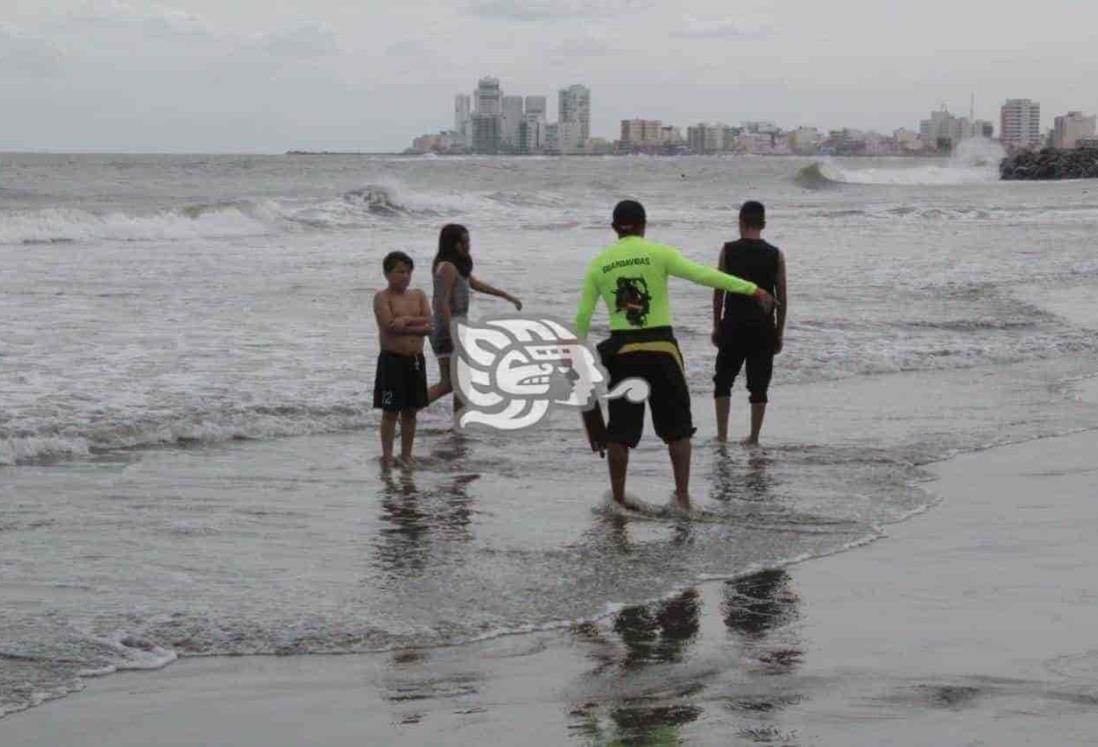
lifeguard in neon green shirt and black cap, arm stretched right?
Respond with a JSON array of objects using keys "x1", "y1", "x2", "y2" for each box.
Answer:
[{"x1": 575, "y1": 200, "x2": 774, "y2": 509}]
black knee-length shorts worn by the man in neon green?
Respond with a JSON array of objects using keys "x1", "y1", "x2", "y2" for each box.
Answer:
[{"x1": 598, "y1": 327, "x2": 695, "y2": 448}]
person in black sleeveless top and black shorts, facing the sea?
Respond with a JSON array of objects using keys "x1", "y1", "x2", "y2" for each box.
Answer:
[{"x1": 713, "y1": 201, "x2": 787, "y2": 444}]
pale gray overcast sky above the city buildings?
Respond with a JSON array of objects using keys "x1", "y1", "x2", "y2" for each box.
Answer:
[{"x1": 0, "y1": 0, "x2": 1098, "y2": 153}]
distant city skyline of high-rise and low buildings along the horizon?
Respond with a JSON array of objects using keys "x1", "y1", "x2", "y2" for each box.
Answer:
[{"x1": 405, "y1": 76, "x2": 1098, "y2": 156}]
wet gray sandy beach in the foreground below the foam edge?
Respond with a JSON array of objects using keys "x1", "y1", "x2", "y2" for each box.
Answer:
[{"x1": 0, "y1": 424, "x2": 1098, "y2": 747}]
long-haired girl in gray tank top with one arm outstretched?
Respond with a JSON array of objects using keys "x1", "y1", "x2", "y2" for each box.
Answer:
[{"x1": 427, "y1": 223, "x2": 523, "y2": 412}]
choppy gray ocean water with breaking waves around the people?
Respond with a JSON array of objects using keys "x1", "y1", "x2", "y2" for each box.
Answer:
[{"x1": 0, "y1": 154, "x2": 1098, "y2": 715}]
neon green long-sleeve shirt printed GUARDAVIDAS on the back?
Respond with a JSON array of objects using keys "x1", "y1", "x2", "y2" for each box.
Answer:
[{"x1": 575, "y1": 236, "x2": 757, "y2": 338}]
